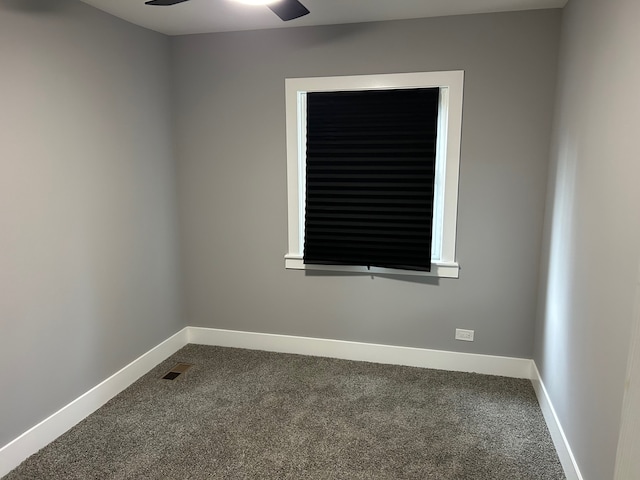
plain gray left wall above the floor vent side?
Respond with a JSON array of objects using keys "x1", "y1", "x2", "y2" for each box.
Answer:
[{"x1": 0, "y1": 0, "x2": 183, "y2": 447}]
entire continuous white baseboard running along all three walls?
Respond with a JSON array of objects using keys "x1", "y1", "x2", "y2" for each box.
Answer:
[{"x1": 0, "y1": 327, "x2": 582, "y2": 480}]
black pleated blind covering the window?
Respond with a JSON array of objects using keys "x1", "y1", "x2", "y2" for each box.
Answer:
[{"x1": 303, "y1": 88, "x2": 440, "y2": 271}]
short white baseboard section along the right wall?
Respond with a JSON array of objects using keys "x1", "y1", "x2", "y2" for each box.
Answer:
[{"x1": 531, "y1": 362, "x2": 583, "y2": 480}]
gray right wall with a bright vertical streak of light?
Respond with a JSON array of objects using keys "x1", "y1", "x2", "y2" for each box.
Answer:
[{"x1": 534, "y1": 0, "x2": 640, "y2": 480}]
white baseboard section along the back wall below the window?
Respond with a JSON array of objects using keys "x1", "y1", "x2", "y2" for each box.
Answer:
[{"x1": 188, "y1": 327, "x2": 532, "y2": 379}]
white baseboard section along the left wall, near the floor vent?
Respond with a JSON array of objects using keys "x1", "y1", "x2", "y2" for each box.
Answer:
[{"x1": 0, "y1": 328, "x2": 188, "y2": 477}]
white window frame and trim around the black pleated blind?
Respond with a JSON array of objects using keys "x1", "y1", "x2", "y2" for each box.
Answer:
[{"x1": 285, "y1": 70, "x2": 464, "y2": 278}]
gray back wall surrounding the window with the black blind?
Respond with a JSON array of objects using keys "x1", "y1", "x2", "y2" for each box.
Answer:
[{"x1": 172, "y1": 10, "x2": 561, "y2": 358}]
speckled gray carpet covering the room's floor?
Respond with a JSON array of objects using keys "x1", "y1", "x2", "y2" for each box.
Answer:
[{"x1": 4, "y1": 345, "x2": 565, "y2": 480}]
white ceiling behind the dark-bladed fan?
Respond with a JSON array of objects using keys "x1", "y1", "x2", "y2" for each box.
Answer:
[{"x1": 82, "y1": 0, "x2": 567, "y2": 35}]
